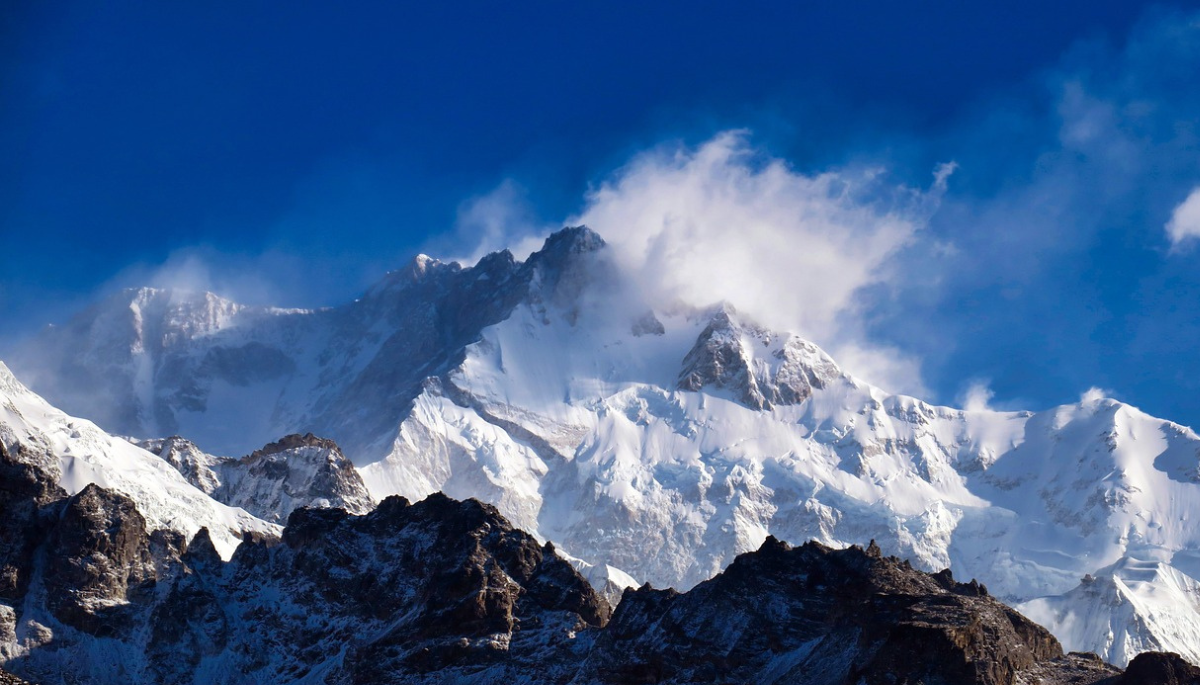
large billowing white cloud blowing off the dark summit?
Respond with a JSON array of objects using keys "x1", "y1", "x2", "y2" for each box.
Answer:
[{"x1": 568, "y1": 131, "x2": 954, "y2": 393}]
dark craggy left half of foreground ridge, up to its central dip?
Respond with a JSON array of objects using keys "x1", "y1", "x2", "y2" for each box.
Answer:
[{"x1": 0, "y1": 475, "x2": 611, "y2": 684}]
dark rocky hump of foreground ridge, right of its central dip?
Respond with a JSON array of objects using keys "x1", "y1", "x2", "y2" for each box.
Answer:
[{"x1": 583, "y1": 537, "x2": 1084, "y2": 685}]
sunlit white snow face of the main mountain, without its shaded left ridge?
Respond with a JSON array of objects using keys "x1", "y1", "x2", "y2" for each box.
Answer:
[{"x1": 362, "y1": 289, "x2": 1200, "y2": 599}]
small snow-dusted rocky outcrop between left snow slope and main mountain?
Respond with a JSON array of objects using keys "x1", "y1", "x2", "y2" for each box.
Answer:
[{"x1": 137, "y1": 433, "x2": 374, "y2": 523}]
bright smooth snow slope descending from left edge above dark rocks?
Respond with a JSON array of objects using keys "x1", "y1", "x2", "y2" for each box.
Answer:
[{"x1": 0, "y1": 363, "x2": 277, "y2": 557}]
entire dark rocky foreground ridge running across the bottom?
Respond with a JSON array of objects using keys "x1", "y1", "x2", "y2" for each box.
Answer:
[{"x1": 0, "y1": 447, "x2": 1200, "y2": 685}]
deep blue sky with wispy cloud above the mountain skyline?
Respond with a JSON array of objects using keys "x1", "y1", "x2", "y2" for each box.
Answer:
[{"x1": 0, "y1": 2, "x2": 1200, "y2": 426}]
